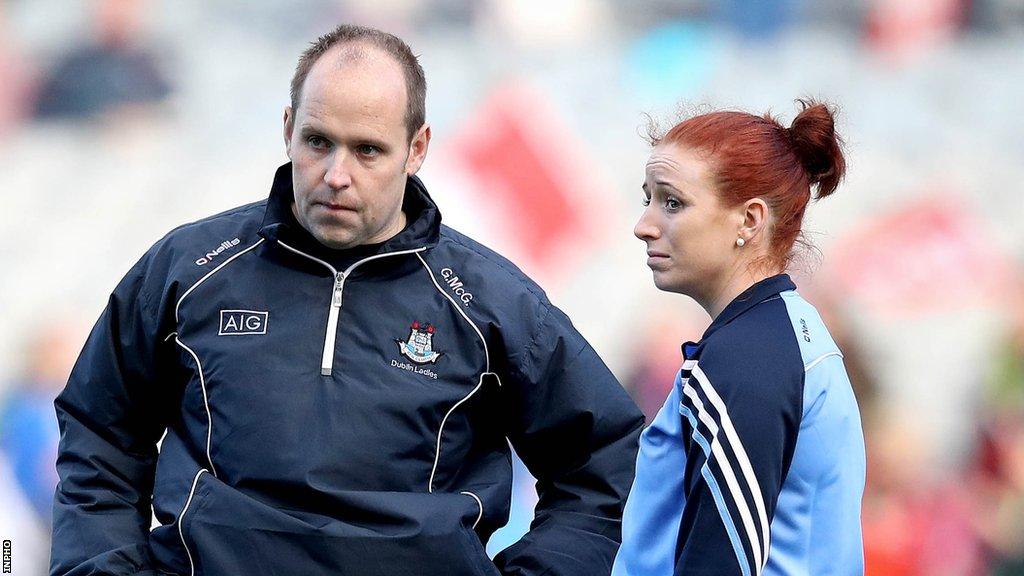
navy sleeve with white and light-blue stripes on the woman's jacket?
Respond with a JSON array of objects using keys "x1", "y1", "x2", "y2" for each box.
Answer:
[{"x1": 675, "y1": 342, "x2": 803, "y2": 576}]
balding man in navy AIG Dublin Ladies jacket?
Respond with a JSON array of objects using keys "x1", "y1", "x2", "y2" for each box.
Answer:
[{"x1": 50, "y1": 26, "x2": 642, "y2": 576}]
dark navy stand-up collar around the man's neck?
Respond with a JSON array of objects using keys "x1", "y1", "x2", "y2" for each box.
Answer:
[{"x1": 259, "y1": 163, "x2": 441, "y2": 261}]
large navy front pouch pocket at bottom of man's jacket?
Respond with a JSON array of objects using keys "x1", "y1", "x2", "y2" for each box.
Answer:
[{"x1": 182, "y1": 474, "x2": 499, "y2": 576}]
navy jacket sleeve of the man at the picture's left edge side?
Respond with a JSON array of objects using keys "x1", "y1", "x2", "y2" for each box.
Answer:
[{"x1": 50, "y1": 249, "x2": 176, "y2": 576}]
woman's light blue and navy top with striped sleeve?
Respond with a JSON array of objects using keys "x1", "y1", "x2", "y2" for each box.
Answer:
[{"x1": 612, "y1": 275, "x2": 865, "y2": 576}]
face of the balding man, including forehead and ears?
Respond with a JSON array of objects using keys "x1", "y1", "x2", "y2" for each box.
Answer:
[{"x1": 285, "y1": 44, "x2": 430, "y2": 249}]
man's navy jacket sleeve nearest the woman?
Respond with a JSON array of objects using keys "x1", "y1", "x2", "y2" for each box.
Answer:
[{"x1": 495, "y1": 304, "x2": 643, "y2": 576}]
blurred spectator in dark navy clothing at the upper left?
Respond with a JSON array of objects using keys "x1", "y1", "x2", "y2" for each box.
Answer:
[{"x1": 36, "y1": 0, "x2": 171, "y2": 119}]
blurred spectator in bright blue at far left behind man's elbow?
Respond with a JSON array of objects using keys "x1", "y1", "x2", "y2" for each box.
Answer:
[{"x1": 0, "y1": 323, "x2": 85, "y2": 526}]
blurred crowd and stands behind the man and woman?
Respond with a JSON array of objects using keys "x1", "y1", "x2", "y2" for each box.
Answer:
[{"x1": 0, "y1": 0, "x2": 1024, "y2": 576}]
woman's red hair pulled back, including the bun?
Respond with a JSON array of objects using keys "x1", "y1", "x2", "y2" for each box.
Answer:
[{"x1": 651, "y1": 100, "x2": 846, "y2": 269}]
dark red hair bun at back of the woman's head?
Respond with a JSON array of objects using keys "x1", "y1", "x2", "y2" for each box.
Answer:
[{"x1": 788, "y1": 99, "x2": 846, "y2": 199}]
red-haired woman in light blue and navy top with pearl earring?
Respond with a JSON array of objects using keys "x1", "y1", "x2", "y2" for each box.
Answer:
[{"x1": 612, "y1": 101, "x2": 864, "y2": 576}]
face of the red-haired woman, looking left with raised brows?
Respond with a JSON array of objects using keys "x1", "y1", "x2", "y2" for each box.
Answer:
[{"x1": 633, "y1": 143, "x2": 743, "y2": 302}]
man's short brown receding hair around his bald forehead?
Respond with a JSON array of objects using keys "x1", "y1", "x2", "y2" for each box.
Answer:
[{"x1": 292, "y1": 24, "x2": 427, "y2": 140}]
